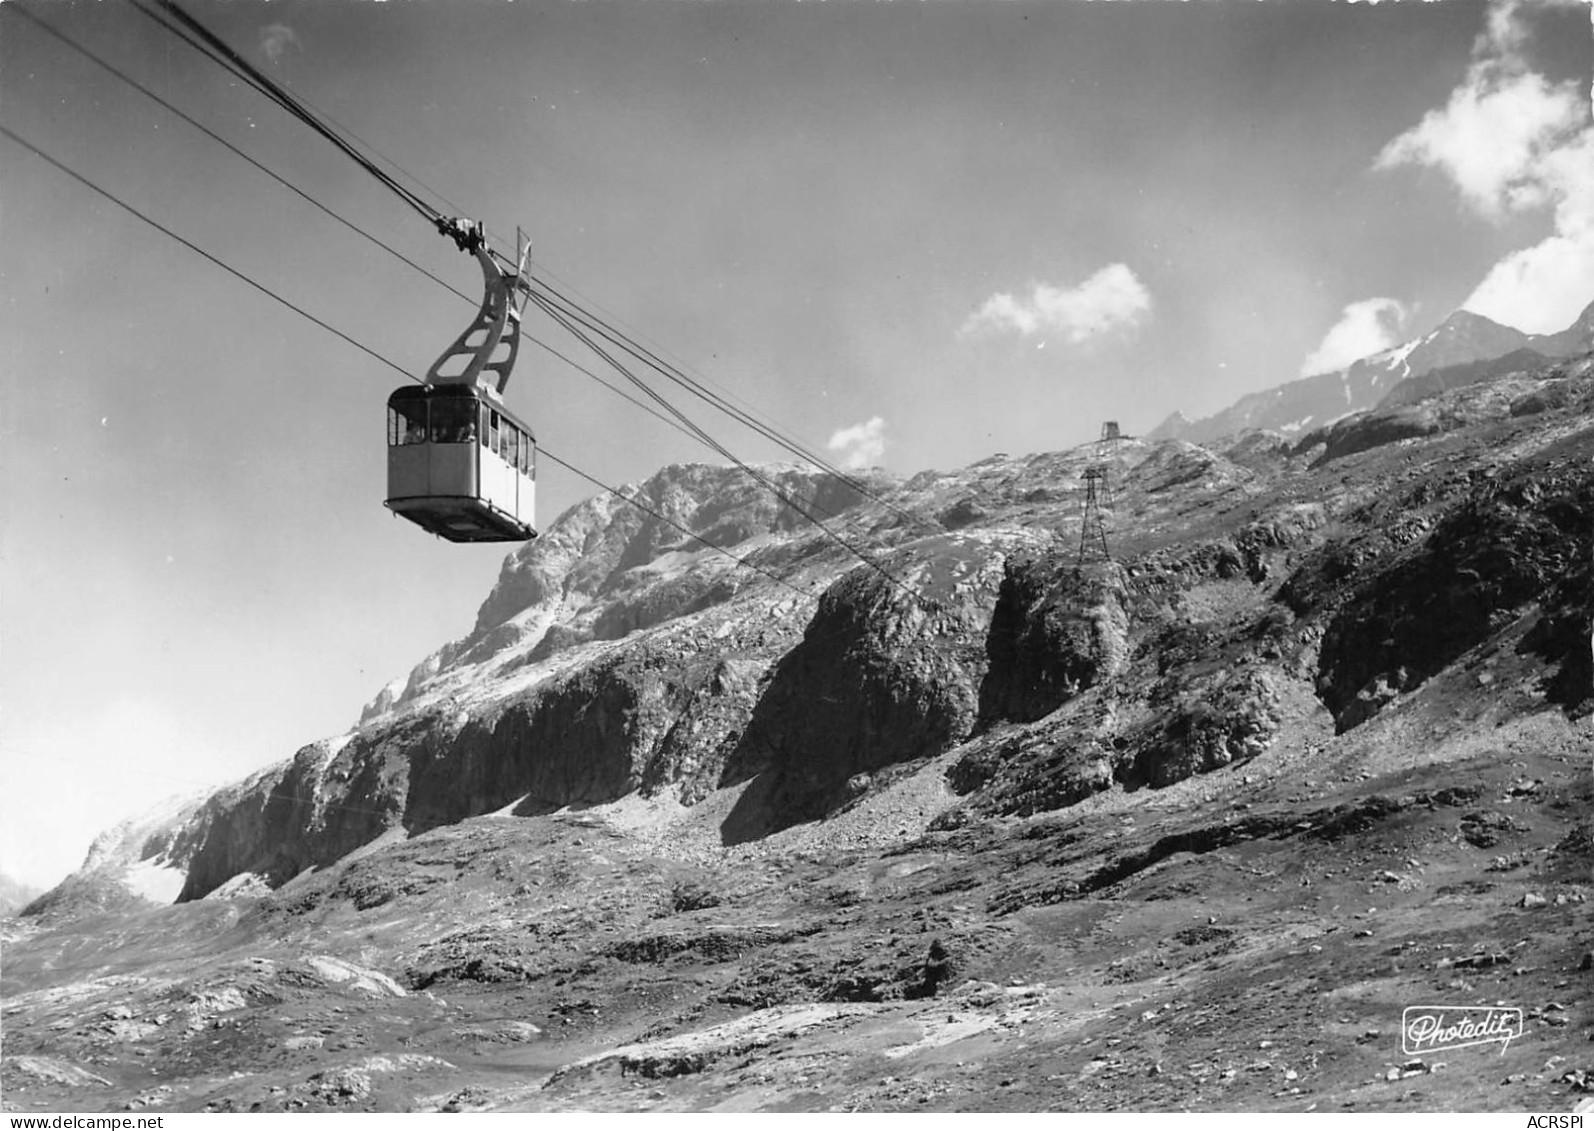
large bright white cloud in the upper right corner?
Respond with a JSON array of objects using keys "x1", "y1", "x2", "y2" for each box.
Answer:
[{"x1": 1374, "y1": 0, "x2": 1594, "y2": 331}]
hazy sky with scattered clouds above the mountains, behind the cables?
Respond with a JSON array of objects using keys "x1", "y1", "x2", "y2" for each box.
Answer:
[{"x1": 0, "y1": 0, "x2": 1594, "y2": 884}]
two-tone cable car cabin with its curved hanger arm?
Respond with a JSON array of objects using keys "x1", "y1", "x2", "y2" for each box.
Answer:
[{"x1": 386, "y1": 220, "x2": 537, "y2": 542}]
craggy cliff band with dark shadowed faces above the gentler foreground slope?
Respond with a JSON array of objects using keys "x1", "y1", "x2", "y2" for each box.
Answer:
[{"x1": 40, "y1": 345, "x2": 1594, "y2": 910}]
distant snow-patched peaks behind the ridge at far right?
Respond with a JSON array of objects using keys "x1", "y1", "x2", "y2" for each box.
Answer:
[{"x1": 1148, "y1": 303, "x2": 1594, "y2": 444}]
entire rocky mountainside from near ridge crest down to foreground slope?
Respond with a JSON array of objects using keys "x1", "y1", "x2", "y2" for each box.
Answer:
[{"x1": 0, "y1": 347, "x2": 1594, "y2": 1110}]
